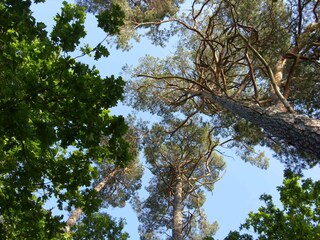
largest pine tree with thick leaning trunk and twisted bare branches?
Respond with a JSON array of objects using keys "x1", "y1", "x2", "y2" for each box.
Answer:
[{"x1": 125, "y1": 0, "x2": 320, "y2": 167}]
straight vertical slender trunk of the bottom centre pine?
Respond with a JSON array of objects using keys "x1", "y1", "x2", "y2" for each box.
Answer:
[{"x1": 172, "y1": 177, "x2": 183, "y2": 240}]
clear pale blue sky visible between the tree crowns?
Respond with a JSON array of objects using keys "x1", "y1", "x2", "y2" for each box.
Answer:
[{"x1": 33, "y1": 0, "x2": 320, "y2": 240}]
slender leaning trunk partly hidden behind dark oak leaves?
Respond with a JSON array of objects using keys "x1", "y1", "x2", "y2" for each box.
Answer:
[{"x1": 64, "y1": 168, "x2": 119, "y2": 233}]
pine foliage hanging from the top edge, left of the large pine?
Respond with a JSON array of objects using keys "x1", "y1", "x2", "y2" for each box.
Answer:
[{"x1": 75, "y1": 0, "x2": 184, "y2": 50}]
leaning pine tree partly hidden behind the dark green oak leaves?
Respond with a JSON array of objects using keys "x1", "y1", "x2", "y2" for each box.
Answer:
[{"x1": 64, "y1": 117, "x2": 143, "y2": 235}]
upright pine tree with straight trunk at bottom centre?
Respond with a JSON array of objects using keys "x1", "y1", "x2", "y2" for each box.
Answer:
[{"x1": 135, "y1": 118, "x2": 225, "y2": 240}]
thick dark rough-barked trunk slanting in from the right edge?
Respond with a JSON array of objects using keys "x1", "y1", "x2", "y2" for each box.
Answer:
[{"x1": 202, "y1": 92, "x2": 320, "y2": 159}]
